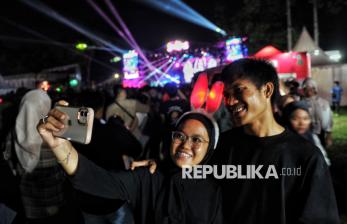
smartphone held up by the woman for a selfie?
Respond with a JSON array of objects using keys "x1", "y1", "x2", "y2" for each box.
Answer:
[{"x1": 53, "y1": 105, "x2": 94, "y2": 144}]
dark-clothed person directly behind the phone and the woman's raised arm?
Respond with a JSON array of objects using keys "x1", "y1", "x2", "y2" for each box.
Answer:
[{"x1": 73, "y1": 90, "x2": 142, "y2": 224}]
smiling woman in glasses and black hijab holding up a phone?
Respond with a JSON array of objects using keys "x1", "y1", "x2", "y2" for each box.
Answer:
[{"x1": 38, "y1": 109, "x2": 222, "y2": 224}]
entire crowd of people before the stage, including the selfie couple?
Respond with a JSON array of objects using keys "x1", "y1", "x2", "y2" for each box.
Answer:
[{"x1": 0, "y1": 59, "x2": 342, "y2": 224}]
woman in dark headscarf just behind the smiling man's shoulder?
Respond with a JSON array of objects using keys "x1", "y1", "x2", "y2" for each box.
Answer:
[{"x1": 283, "y1": 101, "x2": 331, "y2": 166}]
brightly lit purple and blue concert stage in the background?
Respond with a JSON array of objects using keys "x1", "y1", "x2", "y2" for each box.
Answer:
[{"x1": 123, "y1": 37, "x2": 247, "y2": 87}]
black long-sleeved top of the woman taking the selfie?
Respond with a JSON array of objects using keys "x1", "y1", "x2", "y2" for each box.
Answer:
[{"x1": 70, "y1": 155, "x2": 222, "y2": 224}]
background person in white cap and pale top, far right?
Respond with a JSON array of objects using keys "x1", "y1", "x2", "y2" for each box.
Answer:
[{"x1": 303, "y1": 78, "x2": 333, "y2": 148}]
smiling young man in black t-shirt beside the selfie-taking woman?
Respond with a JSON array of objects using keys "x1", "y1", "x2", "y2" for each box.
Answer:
[{"x1": 213, "y1": 59, "x2": 339, "y2": 224}]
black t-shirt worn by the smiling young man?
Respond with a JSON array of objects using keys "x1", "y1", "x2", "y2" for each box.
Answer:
[{"x1": 212, "y1": 128, "x2": 339, "y2": 224}]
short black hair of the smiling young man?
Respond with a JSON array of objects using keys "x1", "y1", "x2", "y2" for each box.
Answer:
[{"x1": 221, "y1": 58, "x2": 280, "y2": 106}]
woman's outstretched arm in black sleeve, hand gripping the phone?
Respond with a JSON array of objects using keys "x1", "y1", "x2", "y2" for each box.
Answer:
[{"x1": 37, "y1": 109, "x2": 140, "y2": 203}]
